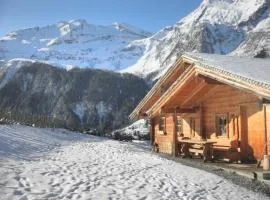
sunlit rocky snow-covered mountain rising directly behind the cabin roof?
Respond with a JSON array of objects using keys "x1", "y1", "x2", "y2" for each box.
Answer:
[{"x1": 123, "y1": 0, "x2": 270, "y2": 80}]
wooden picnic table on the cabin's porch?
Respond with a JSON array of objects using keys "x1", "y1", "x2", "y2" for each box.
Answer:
[{"x1": 179, "y1": 139, "x2": 216, "y2": 162}]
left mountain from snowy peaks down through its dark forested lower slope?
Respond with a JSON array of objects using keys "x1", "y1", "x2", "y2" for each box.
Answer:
[{"x1": 0, "y1": 20, "x2": 150, "y2": 130}]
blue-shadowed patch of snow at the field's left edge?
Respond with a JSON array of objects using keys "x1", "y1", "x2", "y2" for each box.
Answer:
[{"x1": 0, "y1": 125, "x2": 86, "y2": 160}]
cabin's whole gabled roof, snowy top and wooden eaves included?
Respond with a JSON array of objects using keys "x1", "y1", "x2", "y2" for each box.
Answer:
[{"x1": 129, "y1": 53, "x2": 270, "y2": 120}]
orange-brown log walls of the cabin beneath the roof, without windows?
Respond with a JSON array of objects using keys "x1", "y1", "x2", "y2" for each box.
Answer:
[{"x1": 153, "y1": 85, "x2": 270, "y2": 160}]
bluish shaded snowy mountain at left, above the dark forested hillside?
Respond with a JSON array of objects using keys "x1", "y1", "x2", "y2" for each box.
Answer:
[{"x1": 0, "y1": 20, "x2": 151, "y2": 70}]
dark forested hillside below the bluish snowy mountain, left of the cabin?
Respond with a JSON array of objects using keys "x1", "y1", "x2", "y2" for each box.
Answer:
[{"x1": 0, "y1": 59, "x2": 148, "y2": 132}]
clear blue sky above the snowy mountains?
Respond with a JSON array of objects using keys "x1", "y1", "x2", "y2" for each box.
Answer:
[{"x1": 0, "y1": 0, "x2": 202, "y2": 36}]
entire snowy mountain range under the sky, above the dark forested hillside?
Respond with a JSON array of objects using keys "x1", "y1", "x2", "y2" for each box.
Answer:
[{"x1": 0, "y1": 0, "x2": 270, "y2": 82}]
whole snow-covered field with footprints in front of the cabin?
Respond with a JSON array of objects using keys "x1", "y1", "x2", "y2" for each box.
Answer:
[{"x1": 0, "y1": 125, "x2": 268, "y2": 200}]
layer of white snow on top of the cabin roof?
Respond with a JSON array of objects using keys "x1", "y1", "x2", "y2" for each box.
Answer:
[{"x1": 184, "y1": 53, "x2": 270, "y2": 89}]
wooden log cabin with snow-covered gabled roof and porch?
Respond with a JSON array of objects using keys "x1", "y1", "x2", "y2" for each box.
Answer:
[{"x1": 130, "y1": 53, "x2": 270, "y2": 161}]
